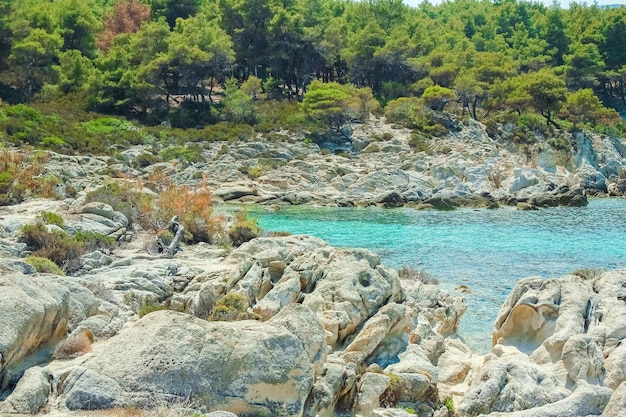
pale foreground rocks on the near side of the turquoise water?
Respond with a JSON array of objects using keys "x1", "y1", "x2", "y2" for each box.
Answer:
[{"x1": 0, "y1": 196, "x2": 626, "y2": 417}]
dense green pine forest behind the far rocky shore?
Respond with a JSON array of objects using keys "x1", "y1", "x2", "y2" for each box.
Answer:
[{"x1": 0, "y1": 0, "x2": 626, "y2": 152}]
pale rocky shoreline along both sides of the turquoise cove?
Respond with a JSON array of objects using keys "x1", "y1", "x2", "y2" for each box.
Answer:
[{"x1": 0, "y1": 120, "x2": 626, "y2": 417}]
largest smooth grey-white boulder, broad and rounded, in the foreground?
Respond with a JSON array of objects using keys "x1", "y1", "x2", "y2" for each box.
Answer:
[{"x1": 59, "y1": 306, "x2": 325, "y2": 416}]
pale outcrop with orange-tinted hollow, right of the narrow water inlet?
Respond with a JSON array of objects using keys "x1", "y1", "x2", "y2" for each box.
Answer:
[{"x1": 450, "y1": 270, "x2": 626, "y2": 416}]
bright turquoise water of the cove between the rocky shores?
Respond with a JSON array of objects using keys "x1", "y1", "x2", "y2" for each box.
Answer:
[{"x1": 253, "y1": 199, "x2": 626, "y2": 353}]
